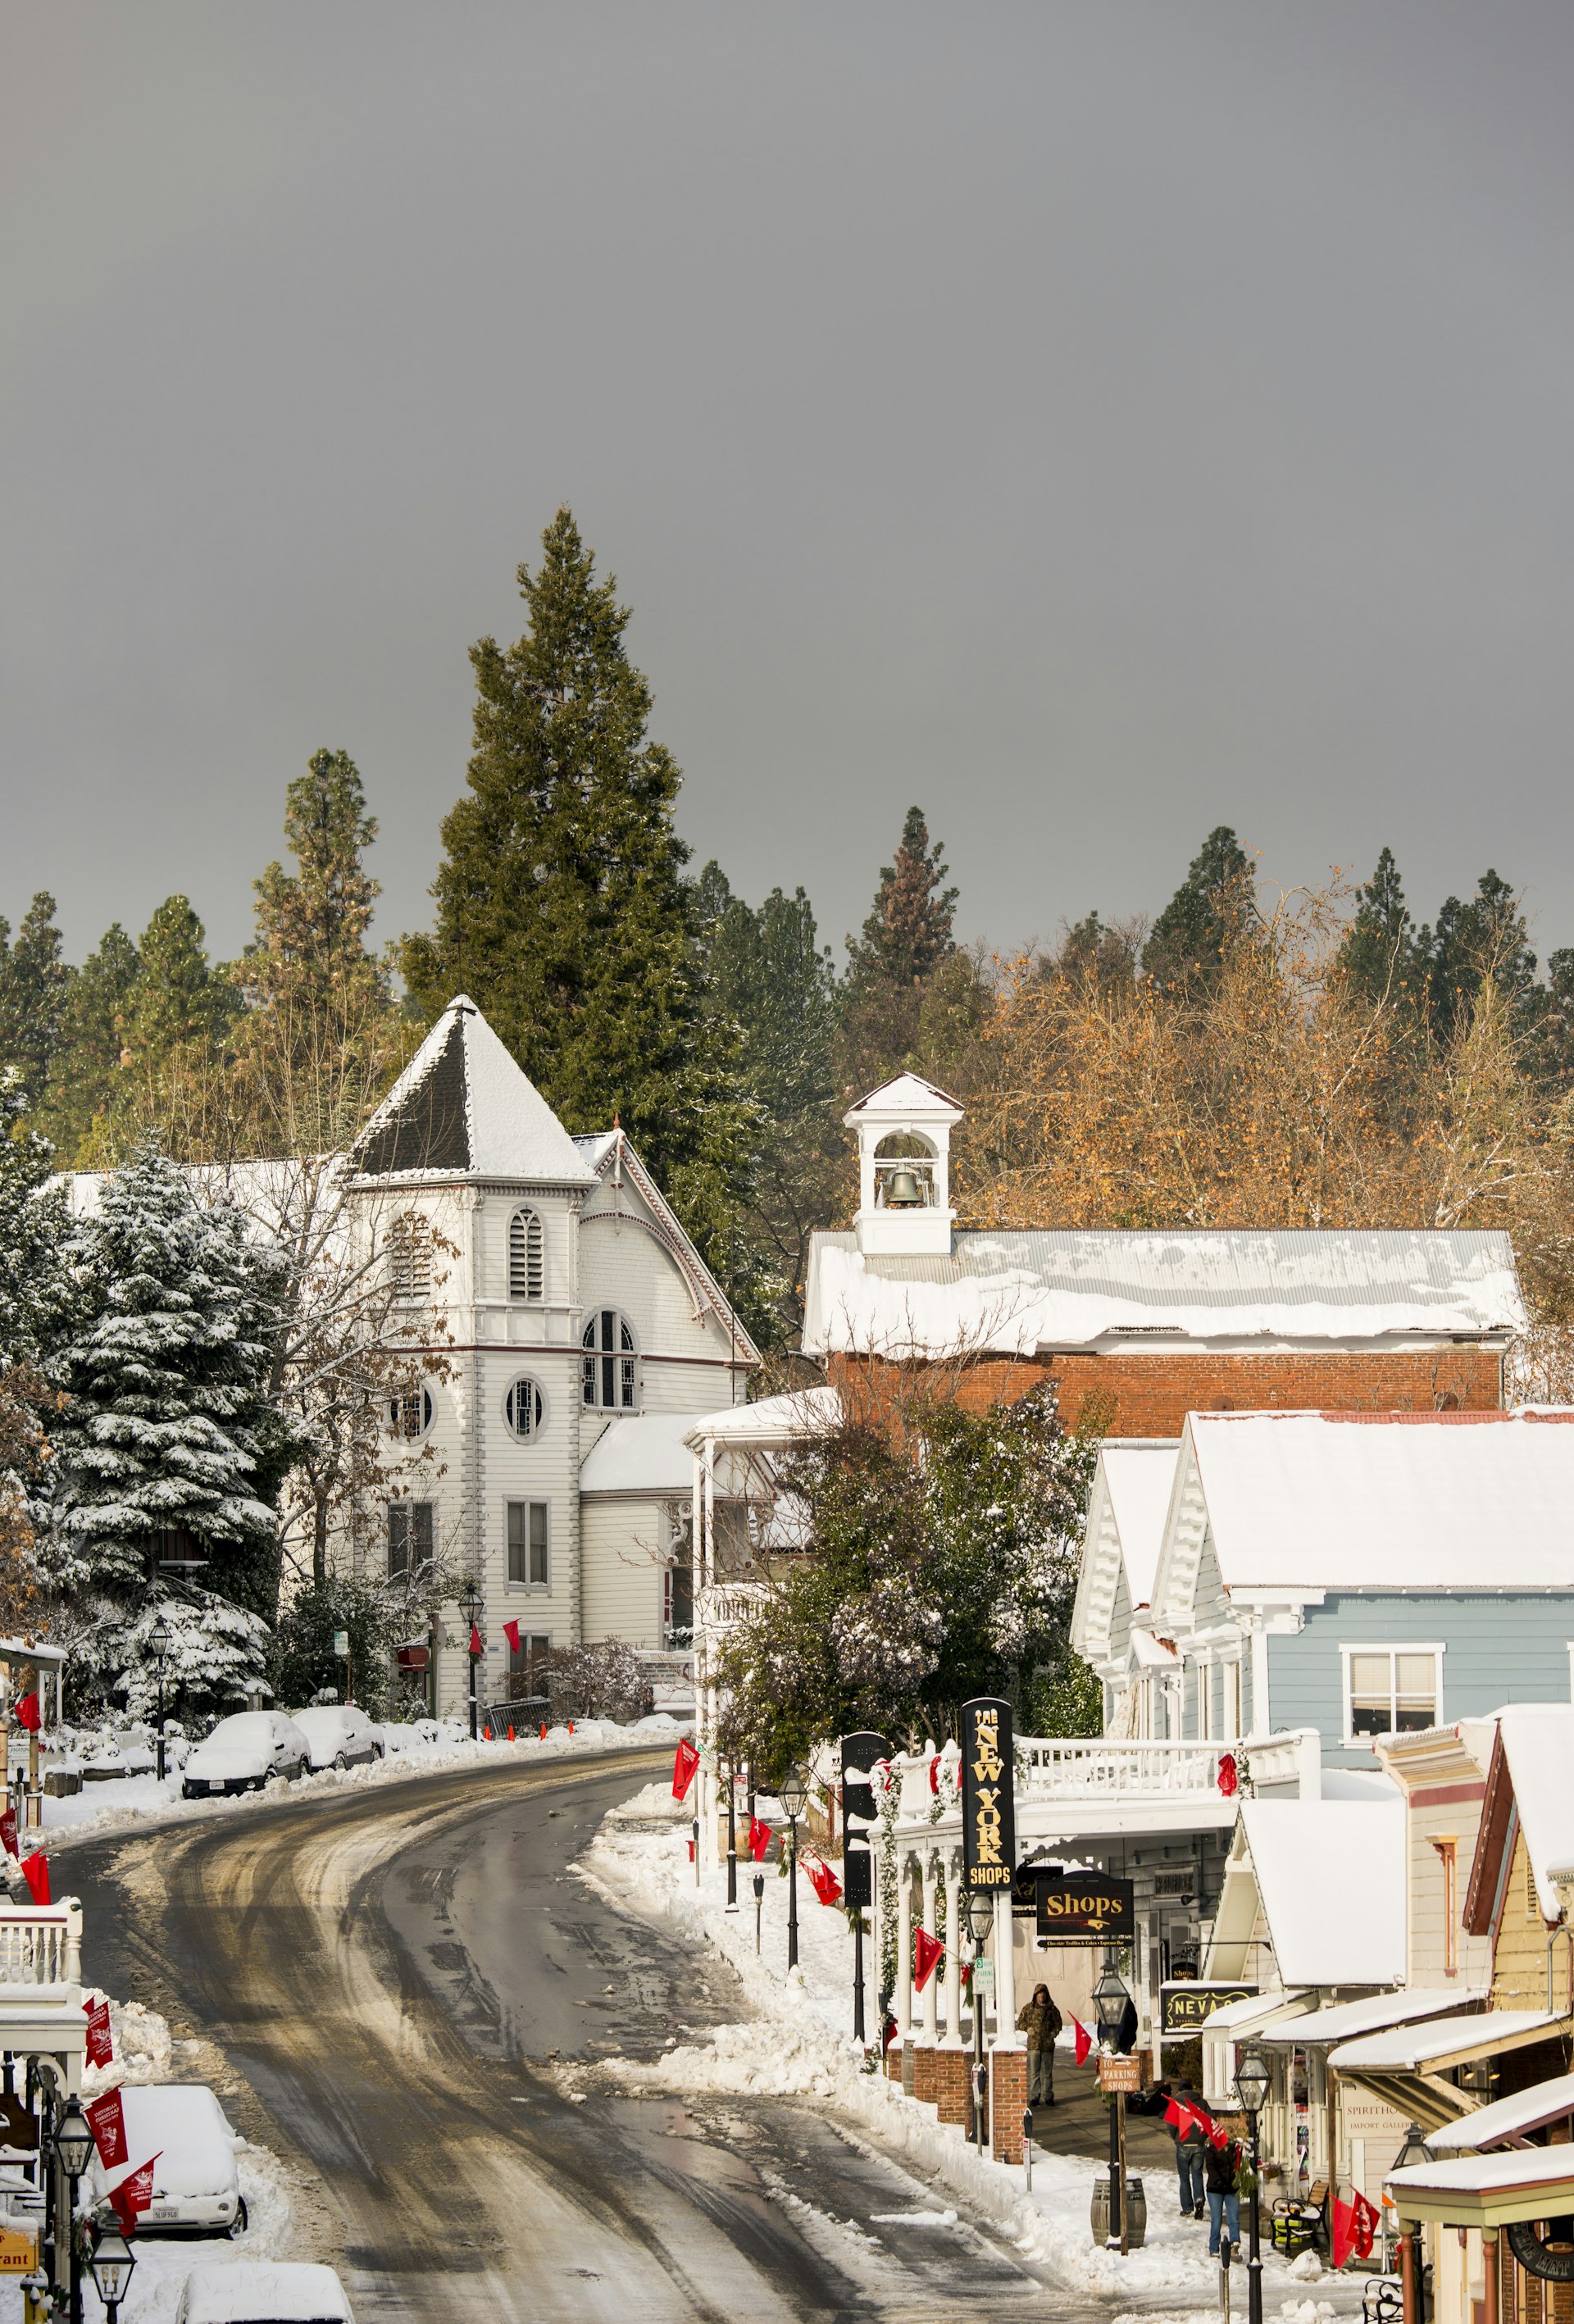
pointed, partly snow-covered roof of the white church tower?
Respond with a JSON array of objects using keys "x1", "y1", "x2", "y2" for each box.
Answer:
[{"x1": 356, "y1": 993, "x2": 595, "y2": 1185}]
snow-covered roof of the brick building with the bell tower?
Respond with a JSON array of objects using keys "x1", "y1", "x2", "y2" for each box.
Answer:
[{"x1": 804, "y1": 1226, "x2": 1525, "y2": 1358}]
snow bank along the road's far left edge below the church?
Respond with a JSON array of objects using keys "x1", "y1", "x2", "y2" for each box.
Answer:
[{"x1": 30, "y1": 1711, "x2": 686, "y2": 1843}]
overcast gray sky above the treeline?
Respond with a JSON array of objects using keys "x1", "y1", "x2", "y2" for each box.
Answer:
[{"x1": 0, "y1": 0, "x2": 1574, "y2": 957}]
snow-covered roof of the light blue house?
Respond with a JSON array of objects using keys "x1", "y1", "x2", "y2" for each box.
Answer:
[{"x1": 1153, "y1": 1411, "x2": 1574, "y2": 1636}]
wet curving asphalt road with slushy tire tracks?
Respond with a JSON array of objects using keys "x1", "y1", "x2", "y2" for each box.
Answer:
[{"x1": 58, "y1": 1754, "x2": 1090, "y2": 2324}]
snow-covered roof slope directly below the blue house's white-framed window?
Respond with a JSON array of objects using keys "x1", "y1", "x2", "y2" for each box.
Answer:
[{"x1": 1241, "y1": 1796, "x2": 1404, "y2": 1985}]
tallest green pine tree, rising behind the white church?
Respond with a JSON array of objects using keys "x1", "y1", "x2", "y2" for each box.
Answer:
[{"x1": 404, "y1": 509, "x2": 748, "y2": 1258}]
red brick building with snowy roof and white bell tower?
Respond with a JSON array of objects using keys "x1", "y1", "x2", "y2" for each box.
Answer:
[{"x1": 804, "y1": 1074, "x2": 1523, "y2": 1439}]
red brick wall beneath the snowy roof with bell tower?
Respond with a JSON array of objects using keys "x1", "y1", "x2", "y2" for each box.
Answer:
[{"x1": 832, "y1": 1348, "x2": 1502, "y2": 1436}]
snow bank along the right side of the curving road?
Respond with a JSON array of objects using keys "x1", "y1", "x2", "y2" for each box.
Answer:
[{"x1": 574, "y1": 1782, "x2": 1362, "y2": 2324}]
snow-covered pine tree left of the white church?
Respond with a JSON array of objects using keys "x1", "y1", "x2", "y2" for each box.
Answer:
[{"x1": 47, "y1": 1146, "x2": 279, "y2": 1692}]
